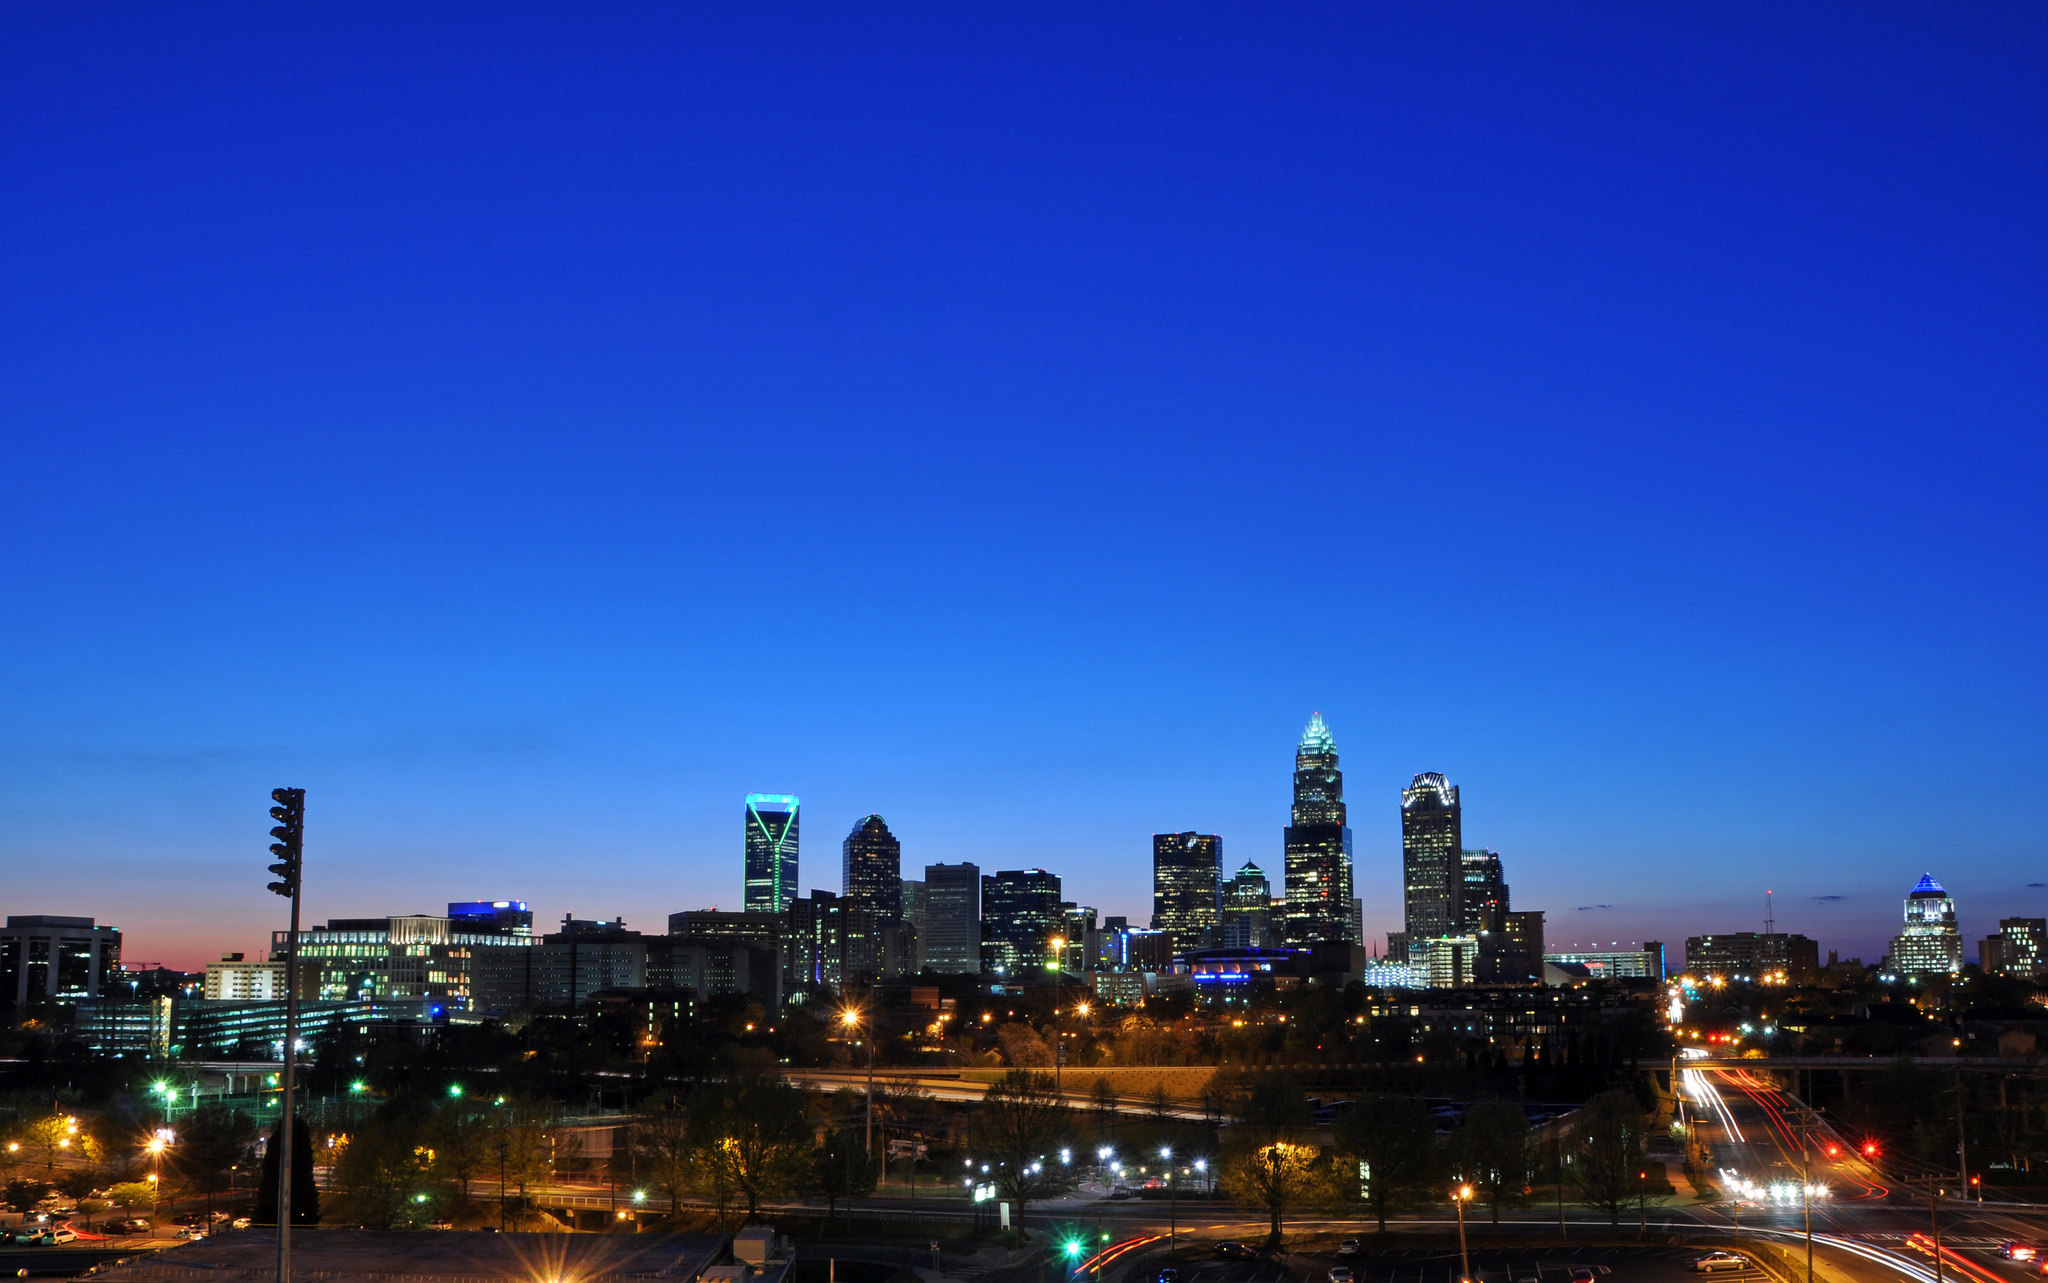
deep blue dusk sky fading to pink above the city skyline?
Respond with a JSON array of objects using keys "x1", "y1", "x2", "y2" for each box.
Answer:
[{"x1": 0, "y1": 2, "x2": 2048, "y2": 965}]
